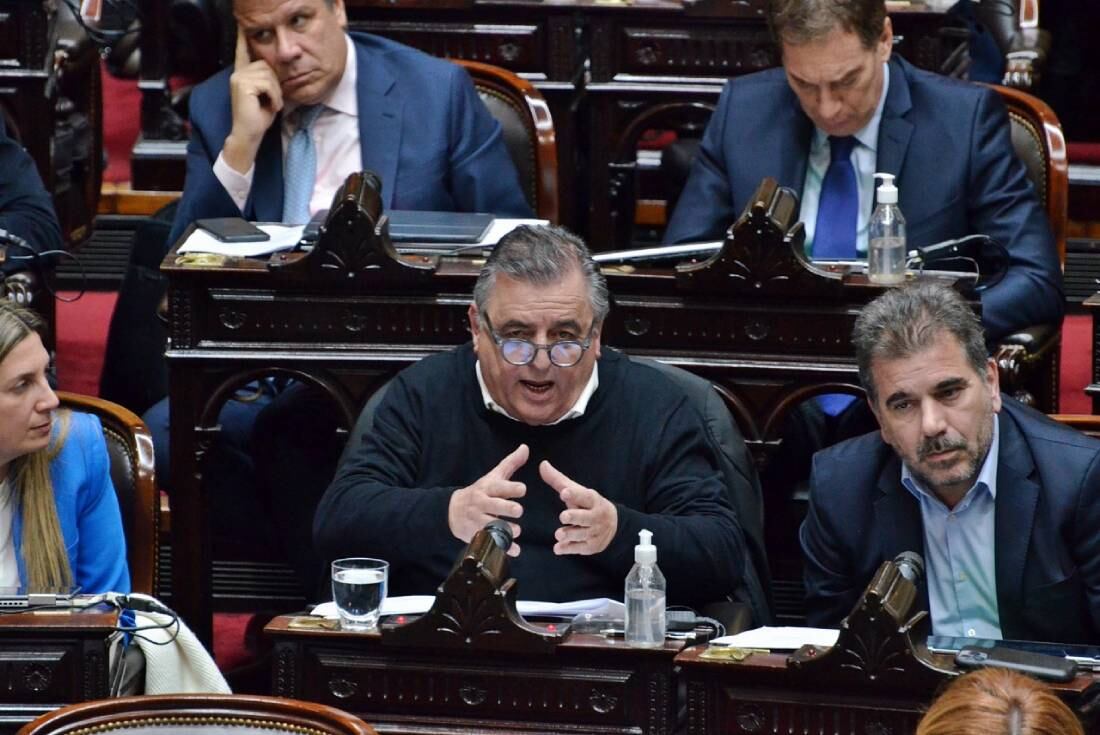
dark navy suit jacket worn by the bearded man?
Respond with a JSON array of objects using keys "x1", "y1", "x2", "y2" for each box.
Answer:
[{"x1": 801, "y1": 397, "x2": 1100, "y2": 644}]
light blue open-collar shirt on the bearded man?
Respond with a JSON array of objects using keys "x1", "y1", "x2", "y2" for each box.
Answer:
[{"x1": 901, "y1": 414, "x2": 1002, "y2": 639}]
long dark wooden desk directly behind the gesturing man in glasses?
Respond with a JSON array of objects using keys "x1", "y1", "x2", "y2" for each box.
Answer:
[{"x1": 162, "y1": 188, "x2": 880, "y2": 644}]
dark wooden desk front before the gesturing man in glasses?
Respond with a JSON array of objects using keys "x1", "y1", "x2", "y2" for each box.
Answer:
[{"x1": 264, "y1": 616, "x2": 682, "y2": 735}]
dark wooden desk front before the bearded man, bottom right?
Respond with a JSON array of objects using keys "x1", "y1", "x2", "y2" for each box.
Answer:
[{"x1": 675, "y1": 647, "x2": 1100, "y2": 735}]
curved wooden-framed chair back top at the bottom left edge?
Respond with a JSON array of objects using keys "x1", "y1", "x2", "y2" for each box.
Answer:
[{"x1": 19, "y1": 694, "x2": 377, "y2": 735}]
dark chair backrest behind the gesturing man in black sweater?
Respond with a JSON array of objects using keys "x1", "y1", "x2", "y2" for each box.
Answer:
[{"x1": 340, "y1": 356, "x2": 772, "y2": 626}]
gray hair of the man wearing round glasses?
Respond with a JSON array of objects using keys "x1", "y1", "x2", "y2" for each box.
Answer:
[{"x1": 474, "y1": 224, "x2": 611, "y2": 325}]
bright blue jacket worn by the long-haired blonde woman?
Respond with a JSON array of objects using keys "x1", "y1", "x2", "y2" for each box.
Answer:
[{"x1": 12, "y1": 413, "x2": 130, "y2": 594}]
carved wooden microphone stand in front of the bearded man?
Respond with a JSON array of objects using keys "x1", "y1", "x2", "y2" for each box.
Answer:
[{"x1": 788, "y1": 561, "x2": 956, "y2": 691}]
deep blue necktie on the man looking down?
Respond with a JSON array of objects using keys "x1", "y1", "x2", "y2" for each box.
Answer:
[{"x1": 814, "y1": 135, "x2": 859, "y2": 261}]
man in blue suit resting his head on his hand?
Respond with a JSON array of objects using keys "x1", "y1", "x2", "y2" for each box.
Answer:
[{"x1": 171, "y1": 0, "x2": 531, "y2": 242}]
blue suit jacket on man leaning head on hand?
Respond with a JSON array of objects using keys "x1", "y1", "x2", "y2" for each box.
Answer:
[{"x1": 169, "y1": 33, "x2": 532, "y2": 243}]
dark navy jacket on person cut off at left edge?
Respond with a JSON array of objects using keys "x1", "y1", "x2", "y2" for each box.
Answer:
[{"x1": 0, "y1": 117, "x2": 64, "y2": 273}]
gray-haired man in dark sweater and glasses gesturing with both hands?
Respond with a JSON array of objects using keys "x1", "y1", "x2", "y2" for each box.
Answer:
[{"x1": 314, "y1": 228, "x2": 745, "y2": 605}]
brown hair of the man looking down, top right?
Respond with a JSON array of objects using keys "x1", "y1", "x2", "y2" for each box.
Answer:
[{"x1": 767, "y1": 0, "x2": 887, "y2": 48}]
